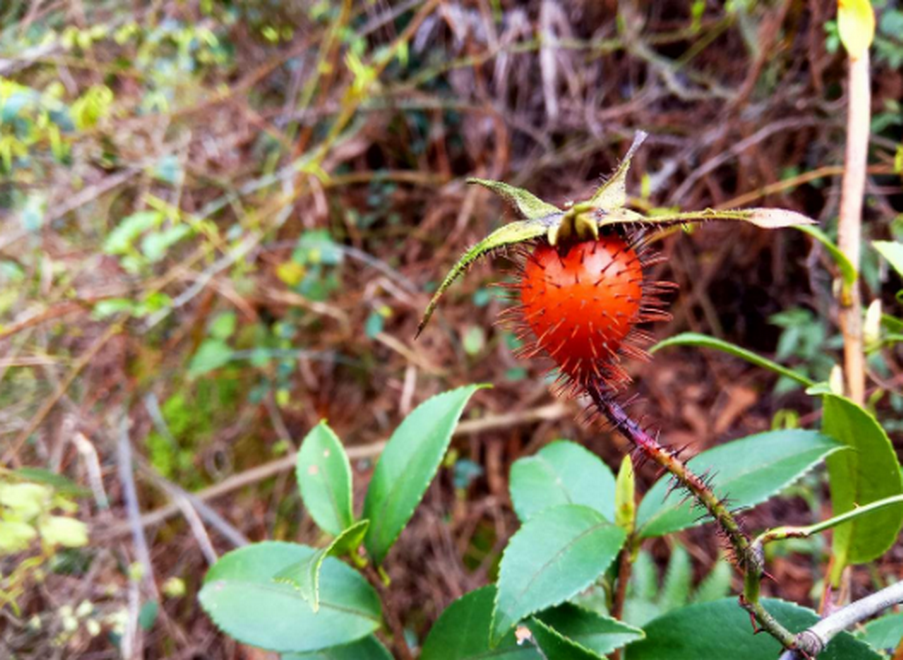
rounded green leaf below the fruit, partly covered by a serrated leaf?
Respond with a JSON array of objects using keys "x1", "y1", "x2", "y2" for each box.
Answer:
[{"x1": 510, "y1": 440, "x2": 615, "y2": 522}]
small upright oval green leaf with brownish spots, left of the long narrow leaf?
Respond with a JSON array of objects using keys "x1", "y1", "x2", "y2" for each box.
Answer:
[{"x1": 295, "y1": 421, "x2": 354, "y2": 536}]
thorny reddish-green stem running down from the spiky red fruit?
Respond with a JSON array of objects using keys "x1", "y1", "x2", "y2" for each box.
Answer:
[{"x1": 586, "y1": 382, "x2": 797, "y2": 649}]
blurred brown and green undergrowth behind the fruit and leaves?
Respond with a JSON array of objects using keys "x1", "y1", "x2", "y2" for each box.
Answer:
[{"x1": 0, "y1": 0, "x2": 903, "y2": 658}]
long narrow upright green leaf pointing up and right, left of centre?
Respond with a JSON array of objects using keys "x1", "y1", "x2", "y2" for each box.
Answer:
[{"x1": 362, "y1": 385, "x2": 485, "y2": 564}]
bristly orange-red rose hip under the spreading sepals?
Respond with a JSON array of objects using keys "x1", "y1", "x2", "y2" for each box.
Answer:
[{"x1": 517, "y1": 234, "x2": 649, "y2": 384}]
